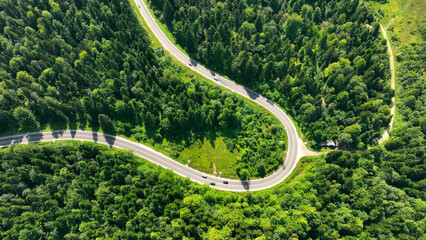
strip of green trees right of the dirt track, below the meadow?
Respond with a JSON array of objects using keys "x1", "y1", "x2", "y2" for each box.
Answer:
[{"x1": 378, "y1": 42, "x2": 426, "y2": 200}]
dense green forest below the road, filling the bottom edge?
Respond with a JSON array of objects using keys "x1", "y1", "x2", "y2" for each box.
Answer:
[{"x1": 0, "y1": 142, "x2": 426, "y2": 240}]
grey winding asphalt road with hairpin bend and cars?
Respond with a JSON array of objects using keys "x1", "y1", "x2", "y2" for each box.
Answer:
[{"x1": 0, "y1": 0, "x2": 316, "y2": 191}]
